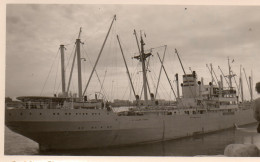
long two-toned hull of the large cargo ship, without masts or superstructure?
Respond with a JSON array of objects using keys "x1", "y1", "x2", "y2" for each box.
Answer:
[{"x1": 6, "y1": 109, "x2": 256, "y2": 150}]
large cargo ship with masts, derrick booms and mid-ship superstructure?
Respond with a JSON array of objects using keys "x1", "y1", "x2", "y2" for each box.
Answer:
[{"x1": 5, "y1": 17, "x2": 256, "y2": 151}]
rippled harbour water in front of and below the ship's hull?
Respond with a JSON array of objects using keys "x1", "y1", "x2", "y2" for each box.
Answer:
[{"x1": 4, "y1": 124, "x2": 260, "y2": 156}]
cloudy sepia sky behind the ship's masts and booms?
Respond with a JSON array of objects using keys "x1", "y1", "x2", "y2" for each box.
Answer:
[{"x1": 5, "y1": 4, "x2": 260, "y2": 100}]
